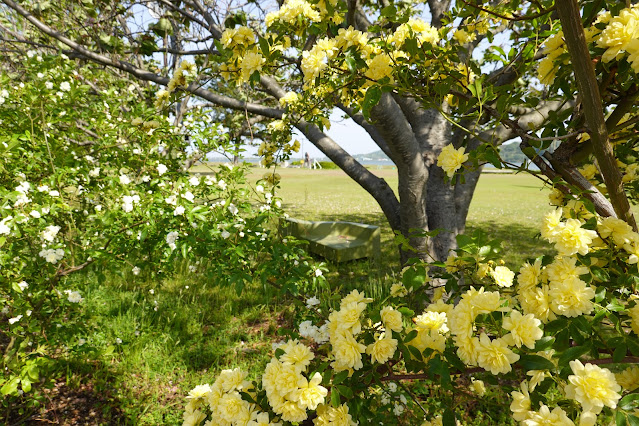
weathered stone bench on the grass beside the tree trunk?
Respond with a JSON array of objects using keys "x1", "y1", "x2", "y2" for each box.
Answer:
[{"x1": 280, "y1": 218, "x2": 380, "y2": 262}]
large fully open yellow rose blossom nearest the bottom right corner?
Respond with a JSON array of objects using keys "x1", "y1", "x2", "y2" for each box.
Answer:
[{"x1": 564, "y1": 360, "x2": 621, "y2": 414}]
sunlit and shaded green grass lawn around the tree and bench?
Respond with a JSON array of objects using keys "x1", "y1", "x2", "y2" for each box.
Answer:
[{"x1": 56, "y1": 168, "x2": 550, "y2": 425}]
